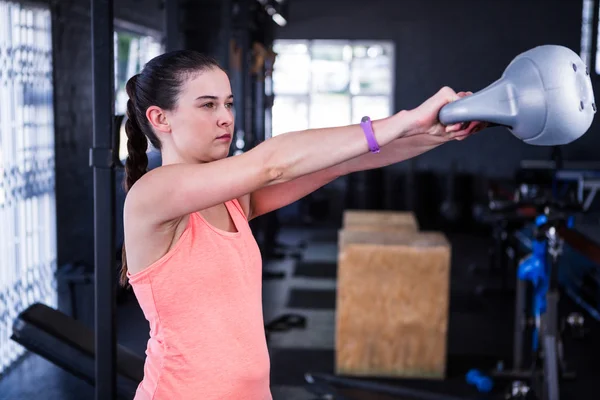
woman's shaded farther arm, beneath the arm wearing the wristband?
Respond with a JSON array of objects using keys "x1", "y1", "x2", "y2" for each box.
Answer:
[{"x1": 249, "y1": 134, "x2": 452, "y2": 219}]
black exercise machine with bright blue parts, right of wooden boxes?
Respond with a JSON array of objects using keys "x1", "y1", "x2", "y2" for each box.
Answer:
[{"x1": 467, "y1": 162, "x2": 600, "y2": 400}]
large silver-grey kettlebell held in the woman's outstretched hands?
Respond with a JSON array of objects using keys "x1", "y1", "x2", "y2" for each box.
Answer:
[{"x1": 439, "y1": 45, "x2": 596, "y2": 146}]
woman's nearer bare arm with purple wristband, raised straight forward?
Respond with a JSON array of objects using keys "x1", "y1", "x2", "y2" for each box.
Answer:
[{"x1": 124, "y1": 111, "x2": 418, "y2": 226}]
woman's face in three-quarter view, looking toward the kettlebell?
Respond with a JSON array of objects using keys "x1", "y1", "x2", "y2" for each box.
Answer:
[{"x1": 166, "y1": 68, "x2": 234, "y2": 162}]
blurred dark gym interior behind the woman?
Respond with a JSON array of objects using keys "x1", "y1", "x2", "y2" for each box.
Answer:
[{"x1": 0, "y1": 0, "x2": 600, "y2": 400}]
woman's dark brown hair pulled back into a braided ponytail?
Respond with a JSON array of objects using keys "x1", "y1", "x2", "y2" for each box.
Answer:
[{"x1": 120, "y1": 50, "x2": 222, "y2": 286}]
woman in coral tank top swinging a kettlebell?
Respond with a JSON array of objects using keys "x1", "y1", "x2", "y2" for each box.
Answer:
[{"x1": 122, "y1": 51, "x2": 482, "y2": 400}]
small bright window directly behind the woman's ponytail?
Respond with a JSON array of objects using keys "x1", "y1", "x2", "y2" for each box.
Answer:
[{"x1": 114, "y1": 30, "x2": 164, "y2": 160}]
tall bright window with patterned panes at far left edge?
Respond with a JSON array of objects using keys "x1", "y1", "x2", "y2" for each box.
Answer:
[{"x1": 0, "y1": 1, "x2": 58, "y2": 375}]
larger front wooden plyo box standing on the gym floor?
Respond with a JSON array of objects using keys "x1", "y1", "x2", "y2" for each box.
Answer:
[{"x1": 335, "y1": 230, "x2": 451, "y2": 379}]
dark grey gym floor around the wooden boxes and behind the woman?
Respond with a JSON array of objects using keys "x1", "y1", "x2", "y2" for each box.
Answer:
[{"x1": 0, "y1": 229, "x2": 600, "y2": 400}]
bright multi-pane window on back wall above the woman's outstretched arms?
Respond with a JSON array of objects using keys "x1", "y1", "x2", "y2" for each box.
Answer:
[{"x1": 272, "y1": 40, "x2": 394, "y2": 136}]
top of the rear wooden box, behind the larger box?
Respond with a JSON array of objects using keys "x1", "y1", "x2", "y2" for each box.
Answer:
[{"x1": 343, "y1": 210, "x2": 419, "y2": 232}]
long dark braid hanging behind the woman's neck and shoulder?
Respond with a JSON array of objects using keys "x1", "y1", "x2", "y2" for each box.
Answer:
[{"x1": 120, "y1": 75, "x2": 148, "y2": 286}]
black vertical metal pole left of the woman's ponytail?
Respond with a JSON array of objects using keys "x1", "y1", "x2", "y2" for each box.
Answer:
[{"x1": 90, "y1": 0, "x2": 116, "y2": 400}]
